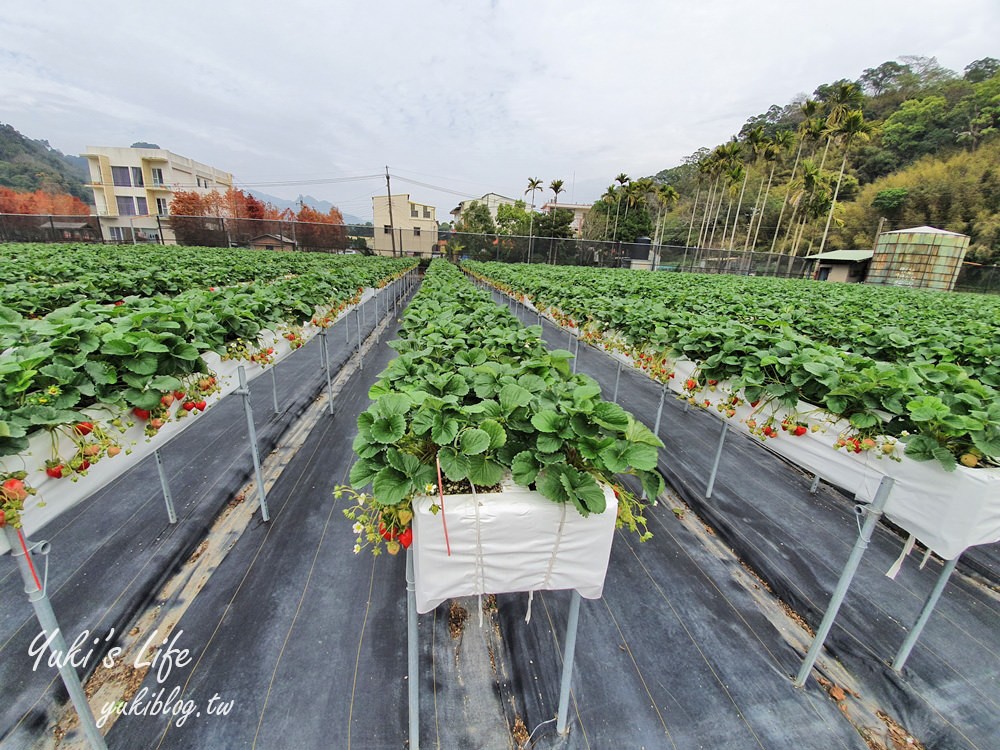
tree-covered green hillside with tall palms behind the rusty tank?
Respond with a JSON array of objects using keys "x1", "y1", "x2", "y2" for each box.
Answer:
[{"x1": 640, "y1": 57, "x2": 1000, "y2": 264}]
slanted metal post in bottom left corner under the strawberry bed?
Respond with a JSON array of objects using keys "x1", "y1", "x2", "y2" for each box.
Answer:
[{"x1": 3, "y1": 524, "x2": 108, "y2": 750}]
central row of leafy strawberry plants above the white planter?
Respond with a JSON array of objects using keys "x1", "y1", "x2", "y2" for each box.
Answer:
[{"x1": 345, "y1": 262, "x2": 663, "y2": 551}]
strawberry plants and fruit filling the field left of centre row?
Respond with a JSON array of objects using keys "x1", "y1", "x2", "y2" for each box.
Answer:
[{"x1": 0, "y1": 244, "x2": 413, "y2": 524}]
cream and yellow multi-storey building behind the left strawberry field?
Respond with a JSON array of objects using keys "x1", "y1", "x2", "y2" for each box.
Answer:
[{"x1": 83, "y1": 146, "x2": 233, "y2": 242}]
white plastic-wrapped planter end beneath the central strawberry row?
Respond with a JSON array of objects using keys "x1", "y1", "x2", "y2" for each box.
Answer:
[{"x1": 413, "y1": 479, "x2": 618, "y2": 614}]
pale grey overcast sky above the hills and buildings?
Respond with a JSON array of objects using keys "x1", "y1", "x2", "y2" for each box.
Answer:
[{"x1": 0, "y1": 0, "x2": 1000, "y2": 220}]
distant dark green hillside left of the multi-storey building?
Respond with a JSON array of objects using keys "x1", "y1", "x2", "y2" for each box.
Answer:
[{"x1": 0, "y1": 123, "x2": 93, "y2": 203}]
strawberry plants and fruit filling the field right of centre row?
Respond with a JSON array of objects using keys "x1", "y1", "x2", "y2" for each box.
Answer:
[{"x1": 466, "y1": 263, "x2": 1000, "y2": 470}]
